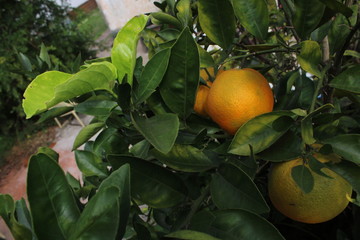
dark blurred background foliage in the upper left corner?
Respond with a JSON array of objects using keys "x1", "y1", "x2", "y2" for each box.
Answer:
[{"x1": 0, "y1": 0, "x2": 95, "y2": 134}]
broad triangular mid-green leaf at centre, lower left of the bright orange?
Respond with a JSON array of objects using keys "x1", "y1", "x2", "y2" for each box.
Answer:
[{"x1": 131, "y1": 113, "x2": 179, "y2": 153}]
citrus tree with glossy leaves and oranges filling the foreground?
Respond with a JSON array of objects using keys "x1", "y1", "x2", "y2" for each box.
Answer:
[{"x1": 0, "y1": 0, "x2": 360, "y2": 240}]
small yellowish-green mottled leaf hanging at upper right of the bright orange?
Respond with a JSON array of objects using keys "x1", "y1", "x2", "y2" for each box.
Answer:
[{"x1": 297, "y1": 40, "x2": 322, "y2": 77}]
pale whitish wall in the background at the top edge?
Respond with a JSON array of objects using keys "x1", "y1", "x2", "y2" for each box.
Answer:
[{"x1": 96, "y1": 0, "x2": 160, "y2": 31}]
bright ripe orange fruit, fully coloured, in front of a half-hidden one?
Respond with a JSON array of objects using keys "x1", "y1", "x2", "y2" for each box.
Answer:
[{"x1": 205, "y1": 68, "x2": 274, "y2": 135}]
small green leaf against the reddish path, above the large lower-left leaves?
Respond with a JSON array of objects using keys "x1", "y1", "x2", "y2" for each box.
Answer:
[{"x1": 75, "y1": 150, "x2": 108, "y2": 178}]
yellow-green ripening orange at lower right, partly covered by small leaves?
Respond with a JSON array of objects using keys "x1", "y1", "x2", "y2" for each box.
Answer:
[{"x1": 268, "y1": 149, "x2": 352, "y2": 223}]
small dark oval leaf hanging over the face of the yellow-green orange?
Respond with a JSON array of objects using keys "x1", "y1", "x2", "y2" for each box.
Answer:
[{"x1": 291, "y1": 165, "x2": 314, "y2": 193}]
